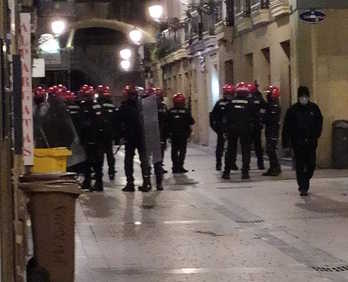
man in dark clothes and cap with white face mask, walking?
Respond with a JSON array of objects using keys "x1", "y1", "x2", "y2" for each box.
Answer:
[{"x1": 282, "y1": 86, "x2": 323, "y2": 196}]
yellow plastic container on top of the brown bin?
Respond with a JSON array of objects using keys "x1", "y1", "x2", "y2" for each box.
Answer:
[{"x1": 32, "y1": 148, "x2": 71, "y2": 173}]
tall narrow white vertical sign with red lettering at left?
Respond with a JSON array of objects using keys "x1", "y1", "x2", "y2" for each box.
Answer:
[{"x1": 19, "y1": 13, "x2": 34, "y2": 166}]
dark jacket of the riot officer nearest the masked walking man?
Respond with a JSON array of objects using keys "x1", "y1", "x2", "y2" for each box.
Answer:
[{"x1": 263, "y1": 101, "x2": 281, "y2": 139}]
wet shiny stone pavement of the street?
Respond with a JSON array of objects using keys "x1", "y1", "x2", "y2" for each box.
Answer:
[{"x1": 76, "y1": 146, "x2": 348, "y2": 282}]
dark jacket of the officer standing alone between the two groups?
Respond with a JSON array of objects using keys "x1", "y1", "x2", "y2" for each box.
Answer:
[{"x1": 168, "y1": 107, "x2": 195, "y2": 139}]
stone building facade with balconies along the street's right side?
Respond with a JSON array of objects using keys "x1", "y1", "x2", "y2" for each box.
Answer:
[{"x1": 150, "y1": 0, "x2": 348, "y2": 167}]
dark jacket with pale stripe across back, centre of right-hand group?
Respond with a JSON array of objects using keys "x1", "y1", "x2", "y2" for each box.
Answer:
[{"x1": 226, "y1": 96, "x2": 257, "y2": 134}]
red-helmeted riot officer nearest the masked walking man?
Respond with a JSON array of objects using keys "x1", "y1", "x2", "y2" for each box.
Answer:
[{"x1": 263, "y1": 85, "x2": 281, "y2": 176}]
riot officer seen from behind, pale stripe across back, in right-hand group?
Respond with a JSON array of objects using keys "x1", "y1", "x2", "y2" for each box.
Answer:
[{"x1": 222, "y1": 82, "x2": 256, "y2": 179}]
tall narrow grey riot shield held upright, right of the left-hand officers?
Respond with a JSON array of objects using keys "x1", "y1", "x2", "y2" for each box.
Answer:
[{"x1": 140, "y1": 96, "x2": 162, "y2": 164}]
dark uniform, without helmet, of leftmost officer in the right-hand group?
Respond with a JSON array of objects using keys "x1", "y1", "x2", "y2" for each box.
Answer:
[{"x1": 210, "y1": 98, "x2": 230, "y2": 170}]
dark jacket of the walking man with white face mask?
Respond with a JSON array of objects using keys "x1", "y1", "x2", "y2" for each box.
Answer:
[{"x1": 282, "y1": 102, "x2": 323, "y2": 148}]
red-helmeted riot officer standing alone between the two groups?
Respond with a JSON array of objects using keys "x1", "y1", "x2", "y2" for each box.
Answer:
[{"x1": 168, "y1": 93, "x2": 195, "y2": 173}]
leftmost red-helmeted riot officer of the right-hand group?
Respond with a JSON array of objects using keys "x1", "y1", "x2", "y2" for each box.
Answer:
[{"x1": 210, "y1": 83, "x2": 238, "y2": 171}]
